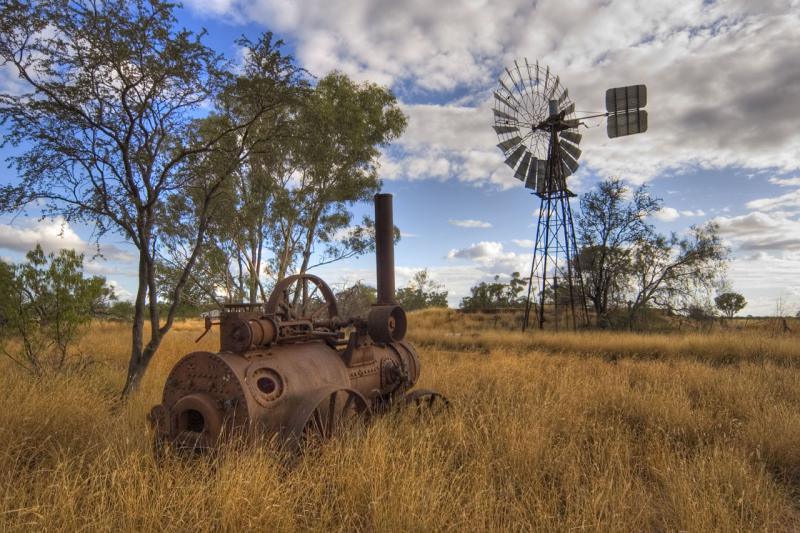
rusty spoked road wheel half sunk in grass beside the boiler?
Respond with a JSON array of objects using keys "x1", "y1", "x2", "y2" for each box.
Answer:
[{"x1": 301, "y1": 389, "x2": 371, "y2": 444}]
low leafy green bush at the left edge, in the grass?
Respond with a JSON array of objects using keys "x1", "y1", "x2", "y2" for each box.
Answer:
[{"x1": 0, "y1": 245, "x2": 113, "y2": 375}]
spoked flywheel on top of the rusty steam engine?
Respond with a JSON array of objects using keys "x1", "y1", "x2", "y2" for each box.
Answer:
[{"x1": 266, "y1": 274, "x2": 339, "y2": 320}]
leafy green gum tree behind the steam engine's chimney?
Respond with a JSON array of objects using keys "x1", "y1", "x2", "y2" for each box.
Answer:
[{"x1": 166, "y1": 72, "x2": 406, "y2": 302}]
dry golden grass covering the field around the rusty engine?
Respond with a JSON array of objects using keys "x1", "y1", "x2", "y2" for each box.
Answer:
[{"x1": 0, "y1": 311, "x2": 800, "y2": 531}]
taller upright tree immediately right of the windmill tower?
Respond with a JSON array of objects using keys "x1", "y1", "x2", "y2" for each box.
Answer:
[{"x1": 578, "y1": 178, "x2": 661, "y2": 325}]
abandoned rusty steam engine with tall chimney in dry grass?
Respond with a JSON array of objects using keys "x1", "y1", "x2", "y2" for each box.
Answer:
[{"x1": 150, "y1": 194, "x2": 447, "y2": 451}]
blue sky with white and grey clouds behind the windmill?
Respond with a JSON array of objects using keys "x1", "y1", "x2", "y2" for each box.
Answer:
[{"x1": 0, "y1": 0, "x2": 800, "y2": 314}]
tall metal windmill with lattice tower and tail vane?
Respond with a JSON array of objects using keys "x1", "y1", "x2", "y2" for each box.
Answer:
[{"x1": 493, "y1": 59, "x2": 647, "y2": 331}]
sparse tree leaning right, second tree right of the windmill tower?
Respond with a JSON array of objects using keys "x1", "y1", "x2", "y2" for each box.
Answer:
[{"x1": 628, "y1": 223, "x2": 728, "y2": 326}]
